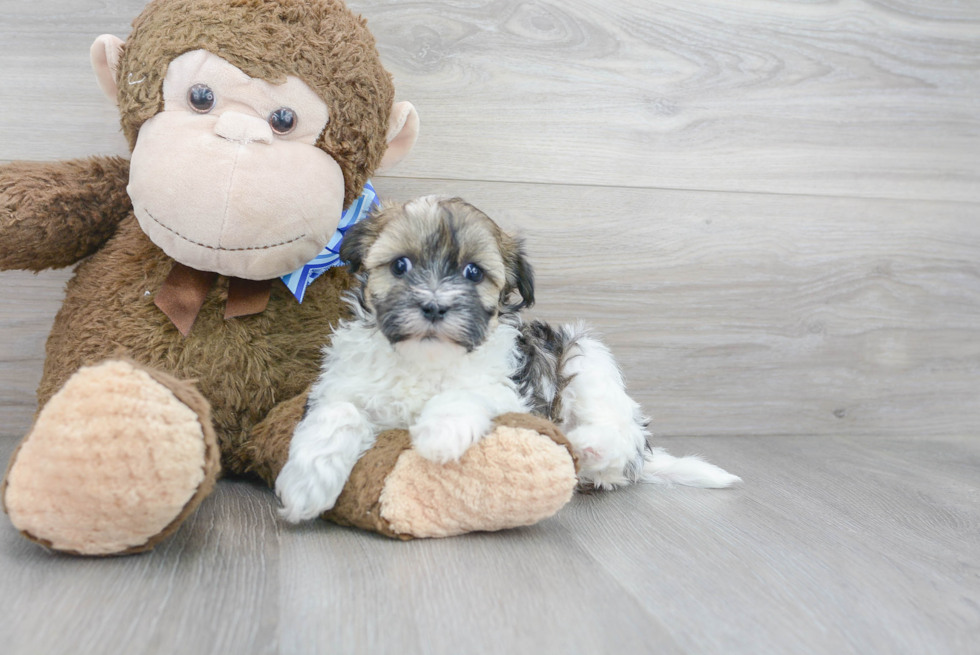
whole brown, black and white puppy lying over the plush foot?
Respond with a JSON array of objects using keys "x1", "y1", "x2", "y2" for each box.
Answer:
[{"x1": 276, "y1": 196, "x2": 739, "y2": 522}]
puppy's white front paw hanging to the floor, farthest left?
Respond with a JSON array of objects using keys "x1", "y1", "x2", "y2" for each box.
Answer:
[{"x1": 276, "y1": 456, "x2": 347, "y2": 523}]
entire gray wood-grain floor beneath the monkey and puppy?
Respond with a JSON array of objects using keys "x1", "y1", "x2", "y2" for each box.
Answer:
[{"x1": 0, "y1": 436, "x2": 980, "y2": 655}]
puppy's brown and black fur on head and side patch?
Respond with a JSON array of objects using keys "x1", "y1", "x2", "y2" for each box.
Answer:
[{"x1": 340, "y1": 196, "x2": 582, "y2": 421}]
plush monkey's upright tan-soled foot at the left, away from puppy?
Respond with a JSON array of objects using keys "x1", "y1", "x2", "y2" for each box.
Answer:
[{"x1": 2, "y1": 361, "x2": 220, "y2": 555}]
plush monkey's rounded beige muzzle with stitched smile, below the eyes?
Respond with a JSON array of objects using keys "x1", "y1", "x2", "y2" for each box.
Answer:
[{"x1": 127, "y1": 111, "x2": 344, "y2": 280}]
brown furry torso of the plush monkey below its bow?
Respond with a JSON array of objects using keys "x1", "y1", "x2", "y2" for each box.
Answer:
[{"x1": 37, "y1": 216, "x2": 348, "y2": 474}]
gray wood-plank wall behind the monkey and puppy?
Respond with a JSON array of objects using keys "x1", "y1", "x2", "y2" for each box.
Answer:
[{"x1": 0, "y1": 0, "x2": 980, "y2": 435}]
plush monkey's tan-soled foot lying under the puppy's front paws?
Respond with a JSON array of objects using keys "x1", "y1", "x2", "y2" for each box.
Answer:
[{"x1": 323, "y1": 414, "x2": 577, "y2": 539}]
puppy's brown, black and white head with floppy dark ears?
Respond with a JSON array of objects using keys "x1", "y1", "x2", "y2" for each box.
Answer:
[{"x1": 340, "y1": 196, "x2": 534, "y2": 350}]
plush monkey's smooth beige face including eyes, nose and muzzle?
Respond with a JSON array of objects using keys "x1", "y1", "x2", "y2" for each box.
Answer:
[{"x1": 123, "y1": 50, "x2": 344, "y2": 280}]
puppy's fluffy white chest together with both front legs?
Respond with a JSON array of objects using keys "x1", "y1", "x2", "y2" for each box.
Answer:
[{"x1": 276, "y1": 312, "x2": 527, "y2": 522}]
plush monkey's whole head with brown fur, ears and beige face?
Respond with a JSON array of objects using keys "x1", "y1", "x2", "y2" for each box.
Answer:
[{"x1": 91, "y1": 0, "x2": 419, "y2": 280}]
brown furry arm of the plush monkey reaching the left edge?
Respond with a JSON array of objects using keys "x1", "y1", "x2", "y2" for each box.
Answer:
[{"x1": 0, "y1": 157, "x2": 132, "y2": 271}]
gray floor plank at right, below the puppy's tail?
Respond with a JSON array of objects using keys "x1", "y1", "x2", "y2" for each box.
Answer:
[{"x1": 561, "y1": 436, "x2": 980, "y2": 655}]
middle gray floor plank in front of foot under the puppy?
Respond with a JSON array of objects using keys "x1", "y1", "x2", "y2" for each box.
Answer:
[{"x1": 280, "y1": 520, "x2": 685, "y2": 655}]
